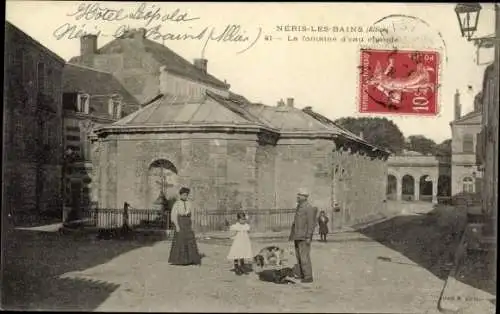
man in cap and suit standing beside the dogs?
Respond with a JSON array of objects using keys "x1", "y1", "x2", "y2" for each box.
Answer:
[{"x1": 288, "y1": 189, "x2": 318, "y2": 283}]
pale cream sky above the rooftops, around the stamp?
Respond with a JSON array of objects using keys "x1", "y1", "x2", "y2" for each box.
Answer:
[{"x1": 6, "y1": 1, "x2": 494, "y2": 143}]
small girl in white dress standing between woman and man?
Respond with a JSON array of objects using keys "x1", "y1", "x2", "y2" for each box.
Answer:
[{"x1": 227, "y1": 213, "x2": 253, "y2": 275}]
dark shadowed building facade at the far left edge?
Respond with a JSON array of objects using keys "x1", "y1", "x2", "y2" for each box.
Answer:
[{"x1": 2, "y1": 22, "x2": 65, "y2": 221}]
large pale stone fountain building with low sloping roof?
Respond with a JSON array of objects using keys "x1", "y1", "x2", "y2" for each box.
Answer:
[{"x1": 95, "y1": 91, "x2": 388, "y2": 229}]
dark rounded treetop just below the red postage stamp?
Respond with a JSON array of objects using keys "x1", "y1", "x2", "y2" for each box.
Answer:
[{"x1": 335, "y1": 117, "x2": 404, "y2": 154}]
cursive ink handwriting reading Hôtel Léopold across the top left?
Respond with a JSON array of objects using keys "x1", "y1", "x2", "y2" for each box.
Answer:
[{"x1": 53, "y1": 3, "x2": 262, "y2": 53}]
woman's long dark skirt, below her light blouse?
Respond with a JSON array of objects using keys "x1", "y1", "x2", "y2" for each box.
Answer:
[{"x1": 168, "y1": 215, "x2": 201, "y2": 265}]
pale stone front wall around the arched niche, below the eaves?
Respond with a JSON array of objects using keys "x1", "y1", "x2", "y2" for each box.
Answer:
[{"x1": 98, "y1": 133, "x2": 257, "y2": 211}]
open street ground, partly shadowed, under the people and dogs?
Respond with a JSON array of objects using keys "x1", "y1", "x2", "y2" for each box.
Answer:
[{"x1": 4, "y1": 204, "x2": 464, "y2": 313}]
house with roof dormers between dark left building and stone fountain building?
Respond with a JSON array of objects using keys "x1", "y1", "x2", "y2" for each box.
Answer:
[{"x1": 63, "y1": 64, "x2": 140, "y2": 217}]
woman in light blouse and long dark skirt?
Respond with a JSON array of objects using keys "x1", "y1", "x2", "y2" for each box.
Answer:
[{"x1": 168, "y1": 188, "x2": 201, "y2": 265}]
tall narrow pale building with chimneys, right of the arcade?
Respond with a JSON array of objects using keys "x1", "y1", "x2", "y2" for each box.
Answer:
[{"x1": 450, "y1": 91, "x2": 482, "y2": 195}]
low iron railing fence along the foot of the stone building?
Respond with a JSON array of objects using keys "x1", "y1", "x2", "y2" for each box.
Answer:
[{"x1": 78, "y1": 206, "x2": 295, "y2": 232}]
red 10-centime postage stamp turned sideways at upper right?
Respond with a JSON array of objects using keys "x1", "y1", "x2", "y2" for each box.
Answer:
[{"x1": 359, "y1": 49, "x2": 439, "y2": 115}]
